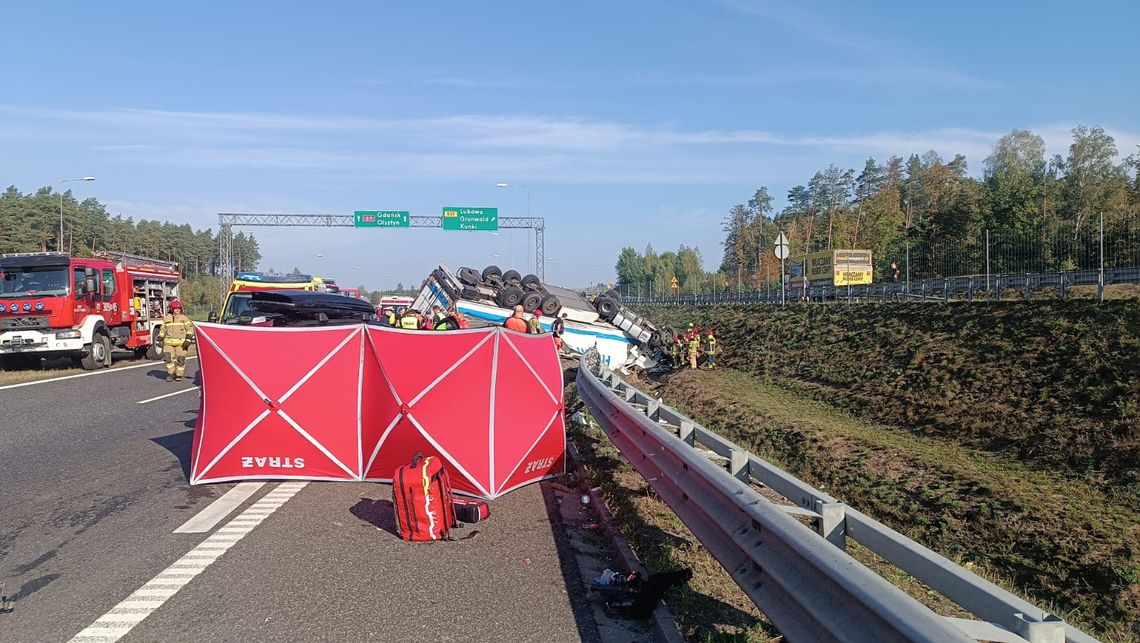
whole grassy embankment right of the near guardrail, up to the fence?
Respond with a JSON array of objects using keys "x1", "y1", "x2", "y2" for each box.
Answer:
[{"x1": 620, "y1": 301, "x2": 1140, "y2": 641}]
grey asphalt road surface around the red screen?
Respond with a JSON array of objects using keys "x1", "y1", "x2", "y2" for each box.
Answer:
[{"x1": 0, "y1": 361, "x2": 596, "y2": 642}]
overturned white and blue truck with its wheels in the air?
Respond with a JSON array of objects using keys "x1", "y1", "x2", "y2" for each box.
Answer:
[{"x1": 412, "y1": 264, "x2": 665, "y2": 368}]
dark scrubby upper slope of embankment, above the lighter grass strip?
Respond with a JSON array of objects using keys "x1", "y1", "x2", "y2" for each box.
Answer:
[{"x1": 640, "y1": 301, "x2": 1140, "y2": 487}]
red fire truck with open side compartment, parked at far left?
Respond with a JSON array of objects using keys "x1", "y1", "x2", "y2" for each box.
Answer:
[{"x1": 0, "y1": 252, "x2": 179, "y2": 371}]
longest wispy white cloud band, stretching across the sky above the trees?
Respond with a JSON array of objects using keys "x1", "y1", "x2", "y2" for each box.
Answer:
[{"x1": 0, "y1": 106, "x2": 1140, "y2": 184}]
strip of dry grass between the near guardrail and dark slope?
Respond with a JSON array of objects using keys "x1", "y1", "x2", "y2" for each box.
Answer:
[{"x1": 659, "y1": 371, "x2": 1140, "y2": 641}]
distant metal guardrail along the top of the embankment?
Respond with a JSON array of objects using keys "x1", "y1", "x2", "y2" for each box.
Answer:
[{"x1": 621, "y1": 267, "x2": 1140, "y2": 306}]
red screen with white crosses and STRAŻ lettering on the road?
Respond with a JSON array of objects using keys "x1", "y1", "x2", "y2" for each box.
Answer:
[{"x1": 190, "y1": 324, "x2": 565, "y2": 498}]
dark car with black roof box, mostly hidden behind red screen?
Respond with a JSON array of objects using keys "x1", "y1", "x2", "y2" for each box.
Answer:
[{"x1": 235, "y1": 291, "x2": 380, "y2": 327}]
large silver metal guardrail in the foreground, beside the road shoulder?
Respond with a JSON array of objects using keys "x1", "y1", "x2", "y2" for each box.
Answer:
[{"x1": 577, "y1": 360, "x2": 1097, "y2": 643}]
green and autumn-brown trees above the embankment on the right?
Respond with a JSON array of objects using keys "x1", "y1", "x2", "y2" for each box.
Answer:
[{"x1": 614, "y1": 125, "x2": 1140, "y2": 295}]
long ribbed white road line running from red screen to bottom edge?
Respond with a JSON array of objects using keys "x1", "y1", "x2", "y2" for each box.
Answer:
[{"x1": 72, "y1": 482, "x2": 307, "y2": 643}]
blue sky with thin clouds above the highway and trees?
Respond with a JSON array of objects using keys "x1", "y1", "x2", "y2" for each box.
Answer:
[{"x1": 0, "y1": 0, "x2": 1140, "y2": 288}]
